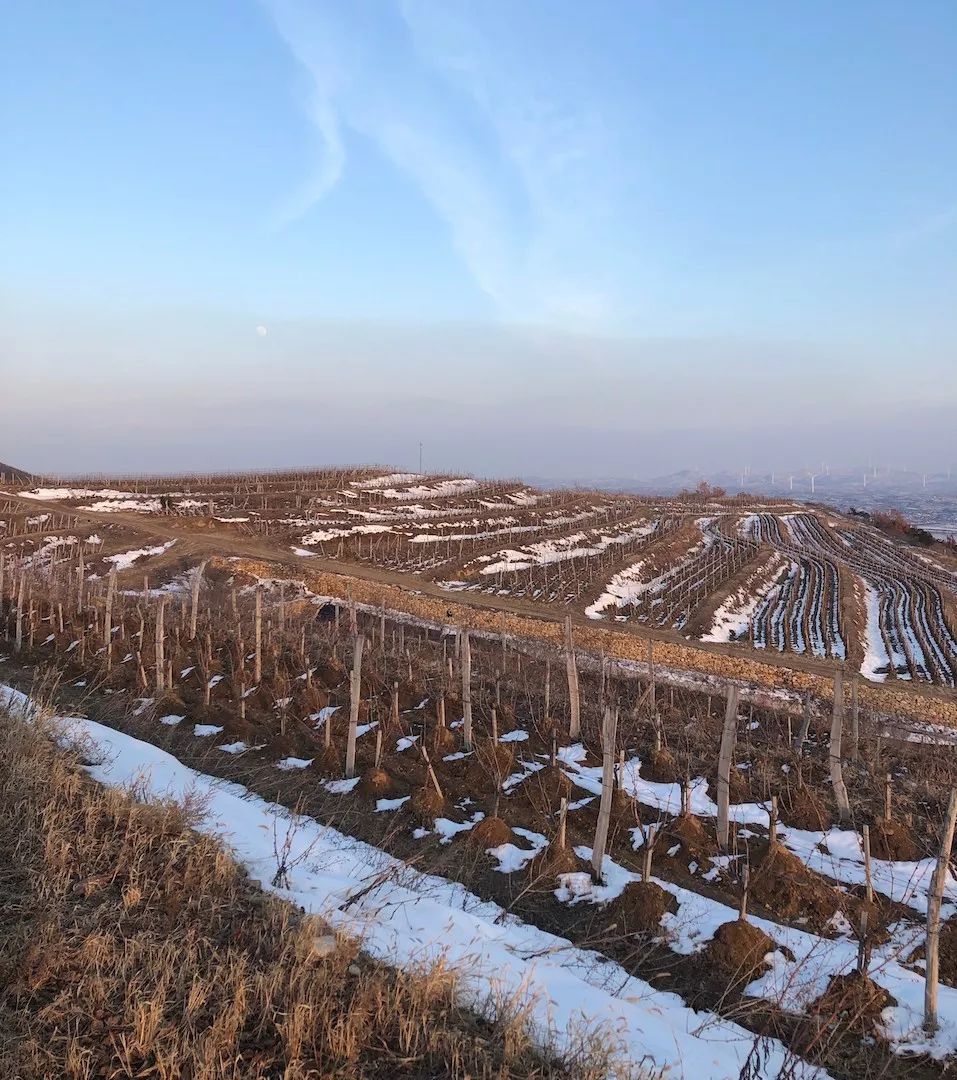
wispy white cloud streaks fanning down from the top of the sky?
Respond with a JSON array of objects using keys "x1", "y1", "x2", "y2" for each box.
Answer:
[{"x1": 265, "y1": 0, "x2": 614, "y2": 325}]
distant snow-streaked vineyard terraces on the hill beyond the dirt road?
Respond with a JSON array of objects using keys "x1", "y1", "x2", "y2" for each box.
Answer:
[{"x1": 0, "y1": 468, "x2": 957, "y2": 687}]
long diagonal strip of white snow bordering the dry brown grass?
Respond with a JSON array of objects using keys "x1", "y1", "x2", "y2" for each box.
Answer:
[{"x1": 0, "y1": 691, "x2": 826, "y2": 1080}]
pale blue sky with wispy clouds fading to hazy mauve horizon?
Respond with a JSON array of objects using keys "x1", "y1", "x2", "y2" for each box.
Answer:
[{"x1": 0, "y1": 0, "x2": 957, "y2": 476}]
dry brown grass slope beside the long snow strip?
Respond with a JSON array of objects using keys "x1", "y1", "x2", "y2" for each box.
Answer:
[{"x1": 0, "y1": 716, "x2": 620, "y2": 1080}]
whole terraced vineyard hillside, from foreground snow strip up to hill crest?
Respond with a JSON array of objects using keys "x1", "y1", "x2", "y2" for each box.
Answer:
[{"x1": 0, "y1": 460, "x2": 957, "y2": 1080}]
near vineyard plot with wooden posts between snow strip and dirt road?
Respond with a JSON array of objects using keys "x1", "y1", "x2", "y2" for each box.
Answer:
[{"x1": 0, "y1": 562, "x2": 957, "y2": 1076}]
